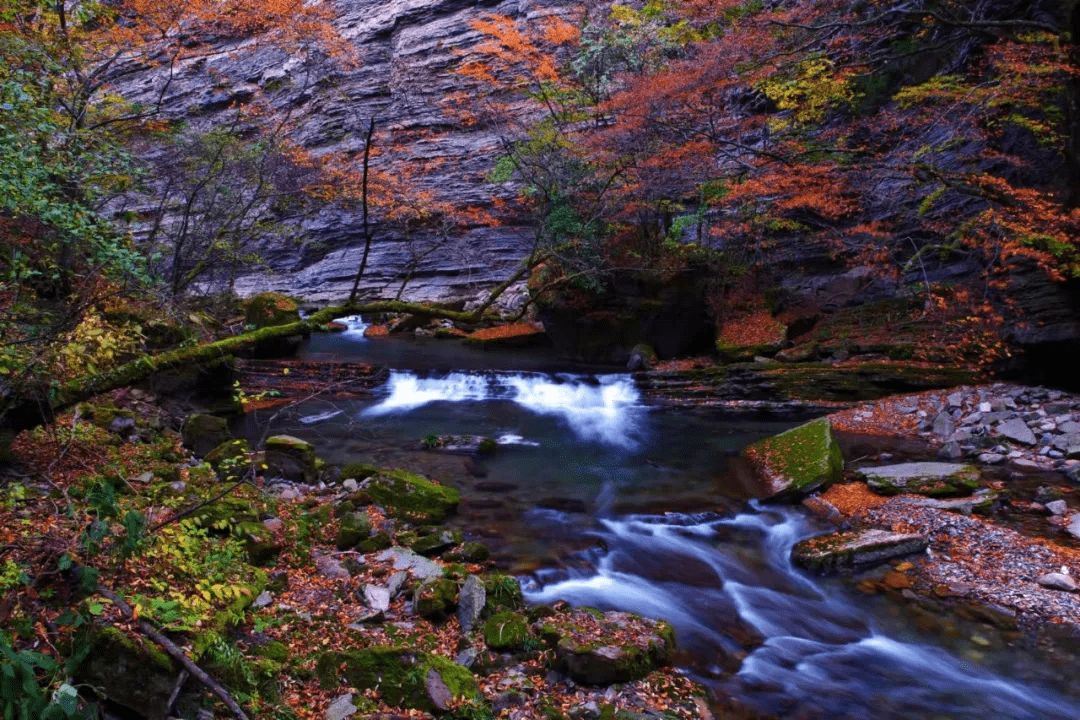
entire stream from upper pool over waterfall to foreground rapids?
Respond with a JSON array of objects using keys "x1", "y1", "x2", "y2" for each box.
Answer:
[{"x1": 240, "y1": 318, "x2": 1080, "y2": 719}]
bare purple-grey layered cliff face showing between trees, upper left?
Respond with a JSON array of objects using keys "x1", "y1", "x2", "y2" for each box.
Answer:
[{"x1": 120, "y1": 0, "x2": 569, "y2": 301}]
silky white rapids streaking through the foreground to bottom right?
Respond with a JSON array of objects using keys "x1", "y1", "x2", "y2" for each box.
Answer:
[{"x1": 525, "y1": 510, "x2": 1080, "y2": 720}]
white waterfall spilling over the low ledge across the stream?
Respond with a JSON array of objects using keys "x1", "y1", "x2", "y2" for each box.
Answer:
[{"x1": 364, "y1": 370, "x2": 645, "y2": 449}]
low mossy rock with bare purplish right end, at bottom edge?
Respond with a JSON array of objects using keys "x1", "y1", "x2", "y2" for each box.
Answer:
[{"x1": 316, "y1": 648, "x2": 480, "y2": 712}]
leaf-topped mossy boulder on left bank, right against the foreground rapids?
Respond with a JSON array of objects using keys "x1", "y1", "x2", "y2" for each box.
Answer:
[{"x1": 538, "y1": 608, "x2": 675, "y2": 685}]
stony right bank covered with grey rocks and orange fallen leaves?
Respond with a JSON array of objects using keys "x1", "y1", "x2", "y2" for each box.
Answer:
[{"x1": 793, "y1": 384, "x2": 1080, "y2": 652}]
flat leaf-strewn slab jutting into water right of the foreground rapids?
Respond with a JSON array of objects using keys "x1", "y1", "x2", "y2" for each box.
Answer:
[{"x1": 792, "y1": 529, "x2": 927, "y2": 572}]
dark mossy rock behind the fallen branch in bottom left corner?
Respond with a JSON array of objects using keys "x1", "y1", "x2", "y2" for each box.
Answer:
[{"x1": 75, "y1": 626, "x2": 180, "y2": 718}]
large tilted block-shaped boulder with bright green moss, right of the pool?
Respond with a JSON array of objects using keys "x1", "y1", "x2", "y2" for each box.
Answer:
[{"x1": 743, "y1": 418, "x2": 843, "y2": 500}]
